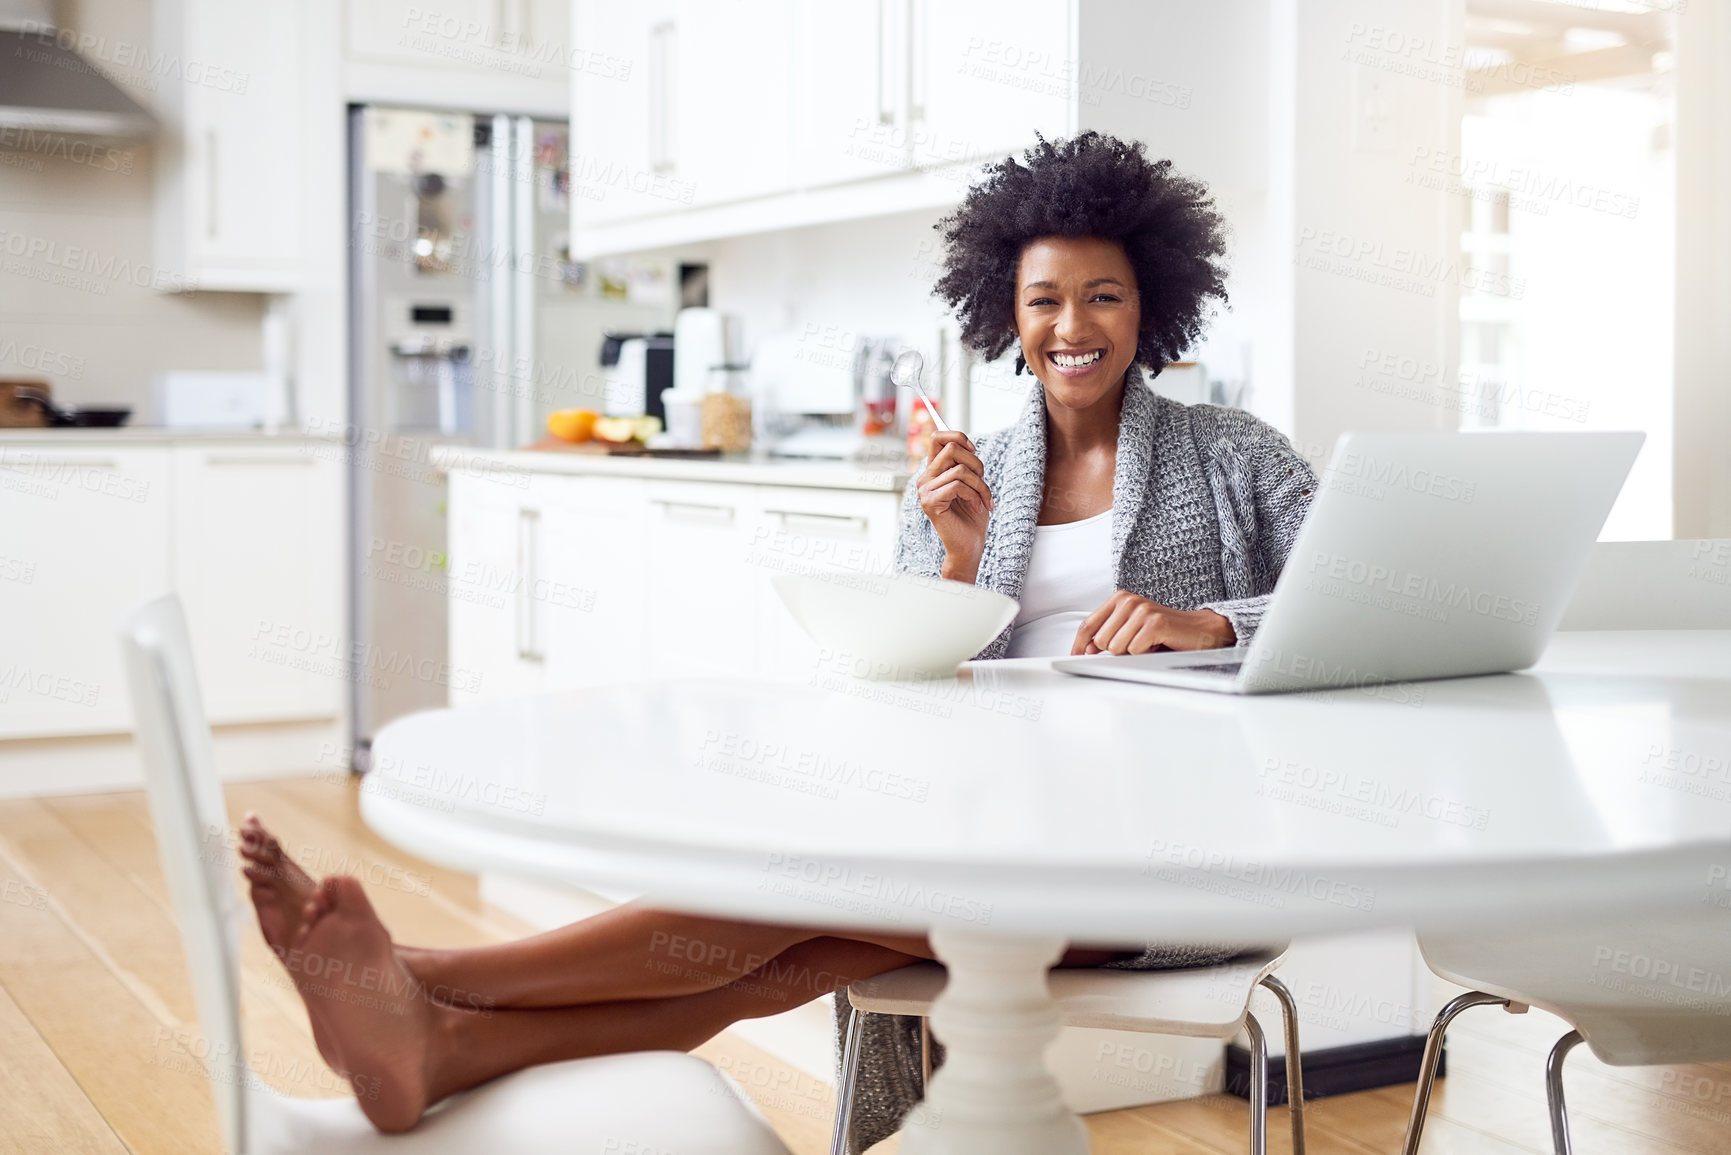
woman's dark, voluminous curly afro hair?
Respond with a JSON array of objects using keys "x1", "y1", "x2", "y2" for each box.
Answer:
[{"x1": 933, "y1": 132, "x2": 1226, "y2": 374}]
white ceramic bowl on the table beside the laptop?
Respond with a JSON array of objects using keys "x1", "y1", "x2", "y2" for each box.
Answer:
[{"x1": 772, "y1": 573, "x2": 1016, "y2": 681}]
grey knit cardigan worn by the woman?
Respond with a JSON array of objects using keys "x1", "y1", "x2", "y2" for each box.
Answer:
[{"x1": 836, "y1": 384, "x2": 1316, "y2": 1153}]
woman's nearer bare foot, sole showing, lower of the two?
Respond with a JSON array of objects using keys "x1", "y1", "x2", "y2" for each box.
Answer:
[{"x1": 282, "y1": 874, "x2": 452, "y2": 1134}]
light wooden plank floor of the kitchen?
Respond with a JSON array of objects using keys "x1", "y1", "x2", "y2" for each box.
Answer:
[{"x1": 0, "y1": 781, "x2": 1731, "y2": 1155}]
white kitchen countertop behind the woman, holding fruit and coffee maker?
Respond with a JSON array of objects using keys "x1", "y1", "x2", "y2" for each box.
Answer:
[{"x1": 431, "y1": 445, "x2": 912, "y2": 494}]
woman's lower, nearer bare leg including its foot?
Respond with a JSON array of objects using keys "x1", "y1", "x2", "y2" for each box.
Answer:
[{"x1": 284, "y1": 876, "x2": 912, "y2": 1132}]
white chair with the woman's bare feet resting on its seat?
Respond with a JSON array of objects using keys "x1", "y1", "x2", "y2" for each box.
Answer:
[{"x1": 119, "y1": 597, "x2": 789, "y2": 1155}]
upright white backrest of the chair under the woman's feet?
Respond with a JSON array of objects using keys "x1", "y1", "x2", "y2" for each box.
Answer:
[{"x1": 118, "y1": 596, "x2": 248, "y2": 1152}]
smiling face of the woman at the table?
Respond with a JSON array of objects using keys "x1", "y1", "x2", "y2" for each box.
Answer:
[{"x1": 1016, "y1": 237, "x2": 1142, "y2": 409}]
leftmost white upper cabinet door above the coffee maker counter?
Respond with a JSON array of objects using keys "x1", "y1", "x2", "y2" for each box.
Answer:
[{"x1": 571, "y1": 0, "x2": 671, "y2": 232}]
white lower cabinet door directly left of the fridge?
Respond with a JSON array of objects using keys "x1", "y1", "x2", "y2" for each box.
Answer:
[{"x1": 170, "y1": 443, "x2": 342, "y2": 724}]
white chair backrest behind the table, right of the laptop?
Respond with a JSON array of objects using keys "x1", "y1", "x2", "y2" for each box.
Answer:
[{"x1": 1556, "y1": 539, "x2": 1731, "y2": 630}]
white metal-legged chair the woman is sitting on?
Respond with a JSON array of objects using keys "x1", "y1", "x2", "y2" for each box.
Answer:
[{"x1": 829, "y1": 947, "x2": 1305, "y2": 1155}]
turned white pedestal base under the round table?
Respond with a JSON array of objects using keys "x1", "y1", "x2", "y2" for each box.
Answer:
[{"x1": 902, "y1": 930, "x2": 1087, "y2": 1155}]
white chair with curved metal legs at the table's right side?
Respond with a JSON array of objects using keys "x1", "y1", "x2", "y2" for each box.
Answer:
[{"x1": 1402, "y1": 540, "x2": 1731, "y2": 1155}]
